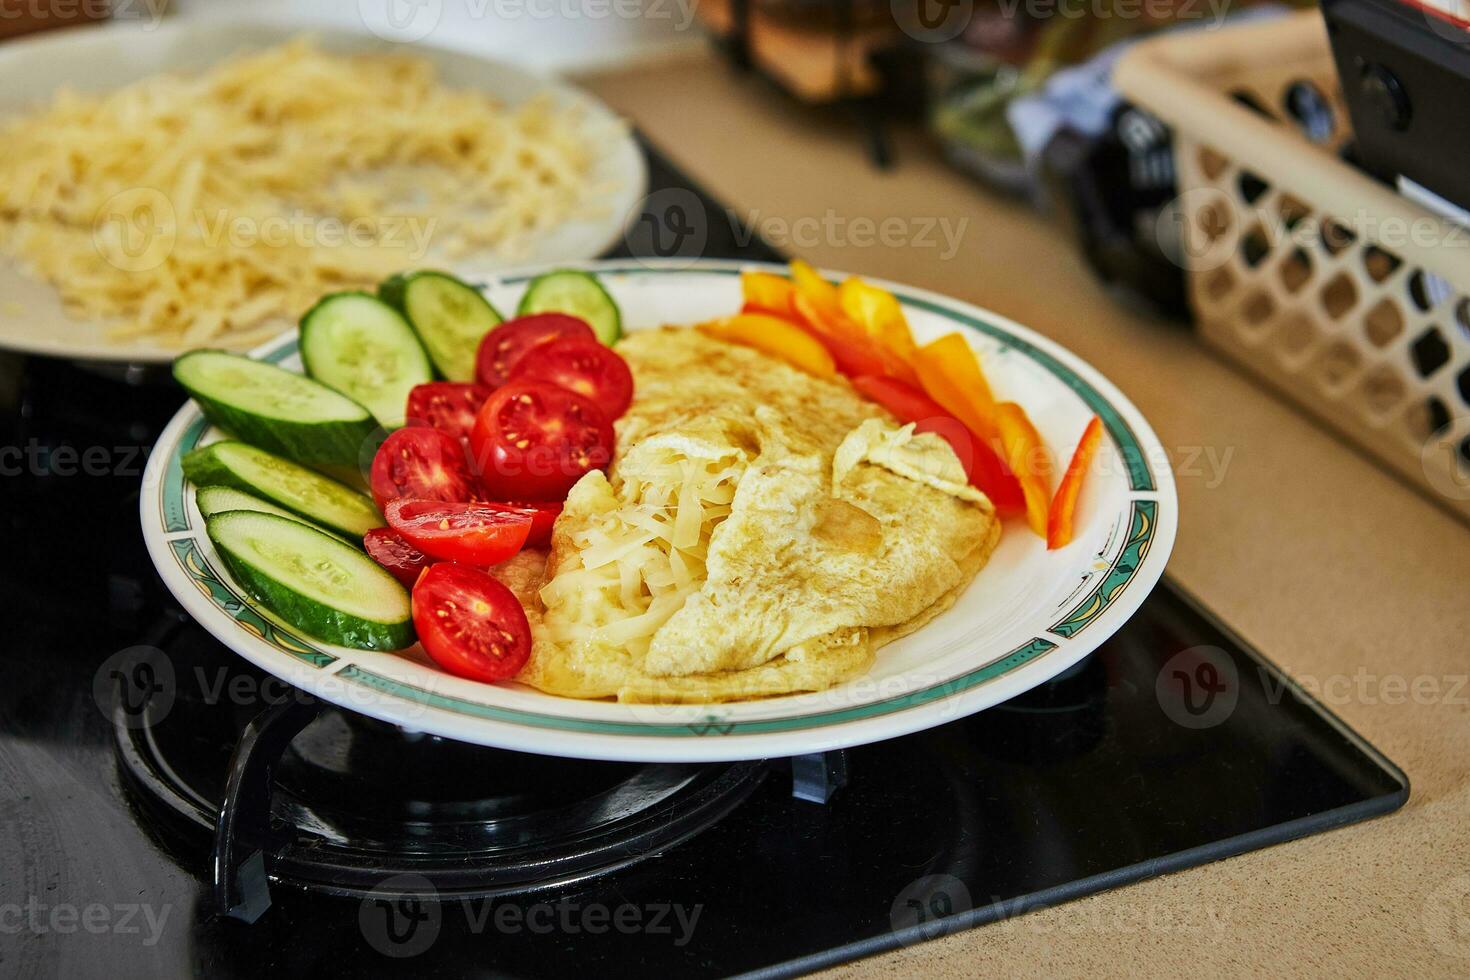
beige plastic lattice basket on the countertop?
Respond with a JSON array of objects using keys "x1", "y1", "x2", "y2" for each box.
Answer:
[{"x1": 1114, "y1": 10, "x2": 1470, "y2": 520}]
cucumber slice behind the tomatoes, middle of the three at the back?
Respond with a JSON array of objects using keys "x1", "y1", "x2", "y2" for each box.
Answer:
[{"x1": 378, "y1": 270, "x2": 503, "y2": 381}]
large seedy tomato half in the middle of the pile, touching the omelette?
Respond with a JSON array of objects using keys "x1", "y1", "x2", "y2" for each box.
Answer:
[{"x1": 469, "y1": 379, "x2": 613, "y2": 501}]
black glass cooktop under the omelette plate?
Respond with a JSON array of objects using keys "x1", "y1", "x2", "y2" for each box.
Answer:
[{"x1": 0, "y1": 135, "x2": 1408, "y2": 977}]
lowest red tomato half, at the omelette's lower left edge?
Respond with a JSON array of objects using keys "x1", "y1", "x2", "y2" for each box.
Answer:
[{"x1": 413, "y1": 561, "x2": 531, "y2": 683}]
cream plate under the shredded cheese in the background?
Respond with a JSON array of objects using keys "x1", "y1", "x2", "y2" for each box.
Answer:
[{"x1": 0, "y1": 21, "x2": 648, "y2": 363}]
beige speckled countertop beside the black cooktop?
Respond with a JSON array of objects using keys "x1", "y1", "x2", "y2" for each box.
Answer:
[{"x1": 582, "y1": 56, "x2": 1470, "y2": 977}]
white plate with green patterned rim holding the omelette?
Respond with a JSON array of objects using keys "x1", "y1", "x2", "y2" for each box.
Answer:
[{"x1": 141, "y1": 260, "x2": 1179, "y2": 761}]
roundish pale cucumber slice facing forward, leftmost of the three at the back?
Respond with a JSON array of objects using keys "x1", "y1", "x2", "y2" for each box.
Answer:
[{"x1": 301, "y1": 292, "x2": 434, "y2": 429}]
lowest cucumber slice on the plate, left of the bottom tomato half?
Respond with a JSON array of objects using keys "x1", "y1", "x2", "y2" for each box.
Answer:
[{"x1": 206, "y1": 510, "x2": 413, "y2": 649}]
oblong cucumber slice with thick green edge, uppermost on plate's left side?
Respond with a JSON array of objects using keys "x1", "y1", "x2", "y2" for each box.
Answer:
[{"x1": 173, "y1": 350, "x2": 378, "y2": 463}]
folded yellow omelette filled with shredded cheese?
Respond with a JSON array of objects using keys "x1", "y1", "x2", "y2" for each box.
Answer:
[{"x1": 495, "y1": 328, "x2": 1000, "y2": 702}]
